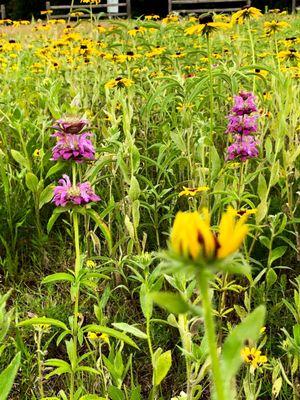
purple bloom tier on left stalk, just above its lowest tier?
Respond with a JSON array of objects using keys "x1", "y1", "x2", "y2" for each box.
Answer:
[{"x1": 52, "y1": 132, "x2": 95, "y2": 162}]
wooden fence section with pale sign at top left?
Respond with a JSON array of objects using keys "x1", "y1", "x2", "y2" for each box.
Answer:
[{"x1": 46, "y1": 0, "x2": 131, "y2": 19}]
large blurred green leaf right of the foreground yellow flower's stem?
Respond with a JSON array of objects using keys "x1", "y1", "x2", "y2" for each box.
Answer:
[{"x1": 222, "y1": 306, "x2": 266, "y2": 388}]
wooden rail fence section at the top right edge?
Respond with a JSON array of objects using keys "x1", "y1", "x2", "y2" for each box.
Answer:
[{"x1": 168, "y1": 0, "x2": 251, "y2": 14}]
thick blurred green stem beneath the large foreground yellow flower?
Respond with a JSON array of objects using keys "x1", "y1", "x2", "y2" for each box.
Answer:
[{"x1": 198, "y1": 269, "x2": 227, "y2": 400}]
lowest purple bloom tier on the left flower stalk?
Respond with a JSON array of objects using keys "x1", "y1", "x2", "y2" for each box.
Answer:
[{"x1": 52, "y1": 175, "x2": 101, "y2": 207}]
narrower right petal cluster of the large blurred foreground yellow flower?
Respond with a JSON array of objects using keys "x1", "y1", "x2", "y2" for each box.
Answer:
[{"x1": 217, "y1": 207, "x2": 248, "y2": 259}]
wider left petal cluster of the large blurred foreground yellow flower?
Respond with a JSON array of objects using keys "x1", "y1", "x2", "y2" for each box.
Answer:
[{"x1": 170, "y1": 209, "x2": 216, "y2": 260}]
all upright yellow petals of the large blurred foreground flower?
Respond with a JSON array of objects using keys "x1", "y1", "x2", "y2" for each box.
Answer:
[{"x1": 170, "y1": 207, "x2": 248, "y2": 260}]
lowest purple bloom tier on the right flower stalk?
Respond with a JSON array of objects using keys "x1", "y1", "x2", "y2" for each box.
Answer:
[{"x1": 227, "y1": 135, "x2": 258, "y2": 161}]
